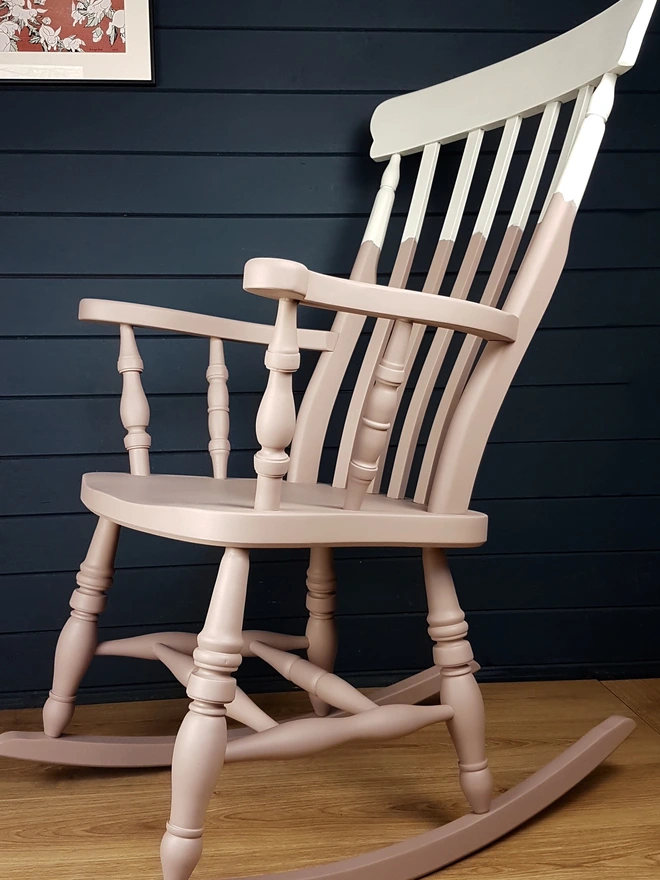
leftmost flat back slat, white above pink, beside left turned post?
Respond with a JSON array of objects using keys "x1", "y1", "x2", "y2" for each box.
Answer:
[{"x1": 333, "y1": 144, "x2": 440, "y2": 488}]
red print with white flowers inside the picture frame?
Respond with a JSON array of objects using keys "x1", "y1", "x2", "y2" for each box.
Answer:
[{"x1": 0, "y1": 0, "x2": 126, "y2": 53}]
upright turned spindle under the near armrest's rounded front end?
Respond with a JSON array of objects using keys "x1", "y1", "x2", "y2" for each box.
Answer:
[{"x1": 254, "y1": 298, "x2": 300, "y2": 510}]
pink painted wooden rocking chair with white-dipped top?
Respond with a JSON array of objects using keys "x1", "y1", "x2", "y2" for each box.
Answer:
[{"x1": 0, "y1": 0, "x2": 655, "y2": 880}]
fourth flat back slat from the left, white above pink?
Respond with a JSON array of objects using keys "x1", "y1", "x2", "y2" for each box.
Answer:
[{"x1": 412, "y1": 101, "x2": 561, "y2": 504}]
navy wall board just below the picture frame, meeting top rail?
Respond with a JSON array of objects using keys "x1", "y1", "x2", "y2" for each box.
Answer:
[{"x1": 0, "y1": 93, "x2": 660, "y2": 155}]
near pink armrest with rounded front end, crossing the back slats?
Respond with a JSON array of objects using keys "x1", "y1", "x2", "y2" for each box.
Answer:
[{"x1": 243, "y1": 258, "x2": 518, "y2": 342}]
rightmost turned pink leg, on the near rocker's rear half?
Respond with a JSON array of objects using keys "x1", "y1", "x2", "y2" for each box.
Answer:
[{"x1": 423, "y1": 548, "x2": 493, "y2": 813}]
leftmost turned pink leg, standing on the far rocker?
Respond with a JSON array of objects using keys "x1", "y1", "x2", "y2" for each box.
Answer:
[{"x1": 43, "y1": 518, "x2": 119, "y2": 737}]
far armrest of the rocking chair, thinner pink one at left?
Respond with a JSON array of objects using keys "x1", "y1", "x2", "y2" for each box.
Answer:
[{"x1": 78, "y1": 299, "x2": 337, "y2": 351}]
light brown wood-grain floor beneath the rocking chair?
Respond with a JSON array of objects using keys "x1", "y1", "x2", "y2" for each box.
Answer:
[{"x1": 0, "y1": 681, "x2": 660, "y2": 880}]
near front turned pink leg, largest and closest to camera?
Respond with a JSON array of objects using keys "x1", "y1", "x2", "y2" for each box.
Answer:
[{"x1": 160, "y1": 547, "x2": 249, "y2": 880}]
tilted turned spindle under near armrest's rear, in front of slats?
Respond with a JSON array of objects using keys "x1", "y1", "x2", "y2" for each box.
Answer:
[{"x1": 344, "y1": 321, "x2": 412, "y2": 510}]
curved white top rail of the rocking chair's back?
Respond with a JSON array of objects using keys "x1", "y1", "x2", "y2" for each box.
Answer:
[{"x1": 371, "y1": 0, "x2": 656, "y2": 160}]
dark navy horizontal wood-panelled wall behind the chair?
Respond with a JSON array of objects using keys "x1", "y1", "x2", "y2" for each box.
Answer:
[{"x1": 0, "y1": 0, "x2": 660, "y2": 706}]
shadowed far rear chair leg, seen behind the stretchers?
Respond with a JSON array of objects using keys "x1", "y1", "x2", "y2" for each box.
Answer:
[{"x1": 305, "y1": 547, "x2": 337, "y2": 716}]
